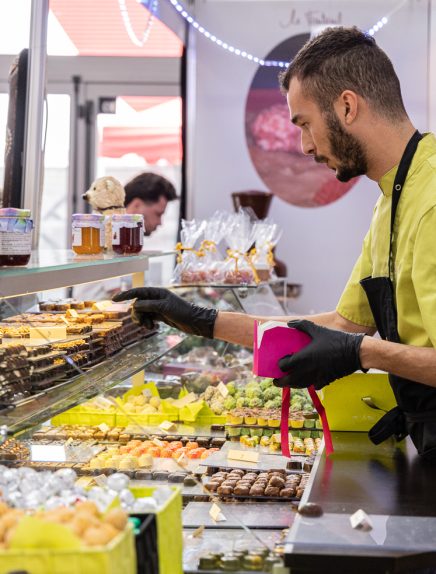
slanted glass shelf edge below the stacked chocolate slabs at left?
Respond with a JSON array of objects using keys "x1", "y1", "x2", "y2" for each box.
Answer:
[{"x1": 0, "y1": 329, "x2": 186, "y2": 435}]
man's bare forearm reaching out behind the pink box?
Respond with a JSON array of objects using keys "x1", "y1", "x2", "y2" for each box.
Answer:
[{"x1": 214, "y1": 311, "x2": 371, "y2": 347}]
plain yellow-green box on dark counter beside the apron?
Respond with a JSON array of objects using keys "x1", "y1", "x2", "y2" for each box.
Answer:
[{"x1": 319, "y1": 373, "x2": 396, "y2": 431}]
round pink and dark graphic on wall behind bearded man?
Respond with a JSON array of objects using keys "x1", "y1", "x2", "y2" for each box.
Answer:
[{"x1": 245, "y1": 34, "x2": 358, "y2": 207}]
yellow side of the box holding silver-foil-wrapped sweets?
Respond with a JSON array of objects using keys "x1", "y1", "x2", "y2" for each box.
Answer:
[{"x1": 131, "y1": 486, "x2": 183, "y2": 574}]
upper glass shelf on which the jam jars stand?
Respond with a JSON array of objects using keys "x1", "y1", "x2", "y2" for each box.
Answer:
[{"x1": 0, "y1": 249, "x2": 172, "y2": 298}]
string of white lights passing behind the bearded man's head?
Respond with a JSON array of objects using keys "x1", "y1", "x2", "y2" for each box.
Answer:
[{"x1": 164, "y1": 0, "x2": 407, "y2": 68}]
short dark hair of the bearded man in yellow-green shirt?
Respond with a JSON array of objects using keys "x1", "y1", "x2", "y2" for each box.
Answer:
[{"x1": 279, "y1": 27, "x2": 407, "y2": 119}]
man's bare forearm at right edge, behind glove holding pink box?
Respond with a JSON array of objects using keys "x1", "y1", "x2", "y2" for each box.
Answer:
[{"x1": 360, "y1": 337, "x2": 436, "y2": 387}]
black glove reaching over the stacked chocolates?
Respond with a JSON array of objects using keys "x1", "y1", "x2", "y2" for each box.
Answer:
[{"x1": 112, "y1": 287, "x2": 218, "y2": 339}]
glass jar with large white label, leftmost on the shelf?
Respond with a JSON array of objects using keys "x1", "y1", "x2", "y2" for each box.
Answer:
[{"x1": 0, "y1": 207, "x2": 33, "y2": 265}]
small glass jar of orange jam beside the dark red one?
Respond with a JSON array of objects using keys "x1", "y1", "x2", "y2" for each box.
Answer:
[{"x1": 72, "y1": 213, "x2": 106, "y2": 255}]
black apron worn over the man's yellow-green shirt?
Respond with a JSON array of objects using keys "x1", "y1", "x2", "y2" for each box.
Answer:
[{"x1": 360, "y1": 131, "x2": 436, "y2": 458}]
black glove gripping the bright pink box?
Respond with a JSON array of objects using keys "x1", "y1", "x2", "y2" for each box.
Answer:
[{"x1": 274, "y1": 319, "x2": 365, "y2": 389}]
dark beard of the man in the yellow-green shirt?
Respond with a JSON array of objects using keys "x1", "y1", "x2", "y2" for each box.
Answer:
[{"x1": 315, "y1": 111, "x2": 368, "y2": 182}]
